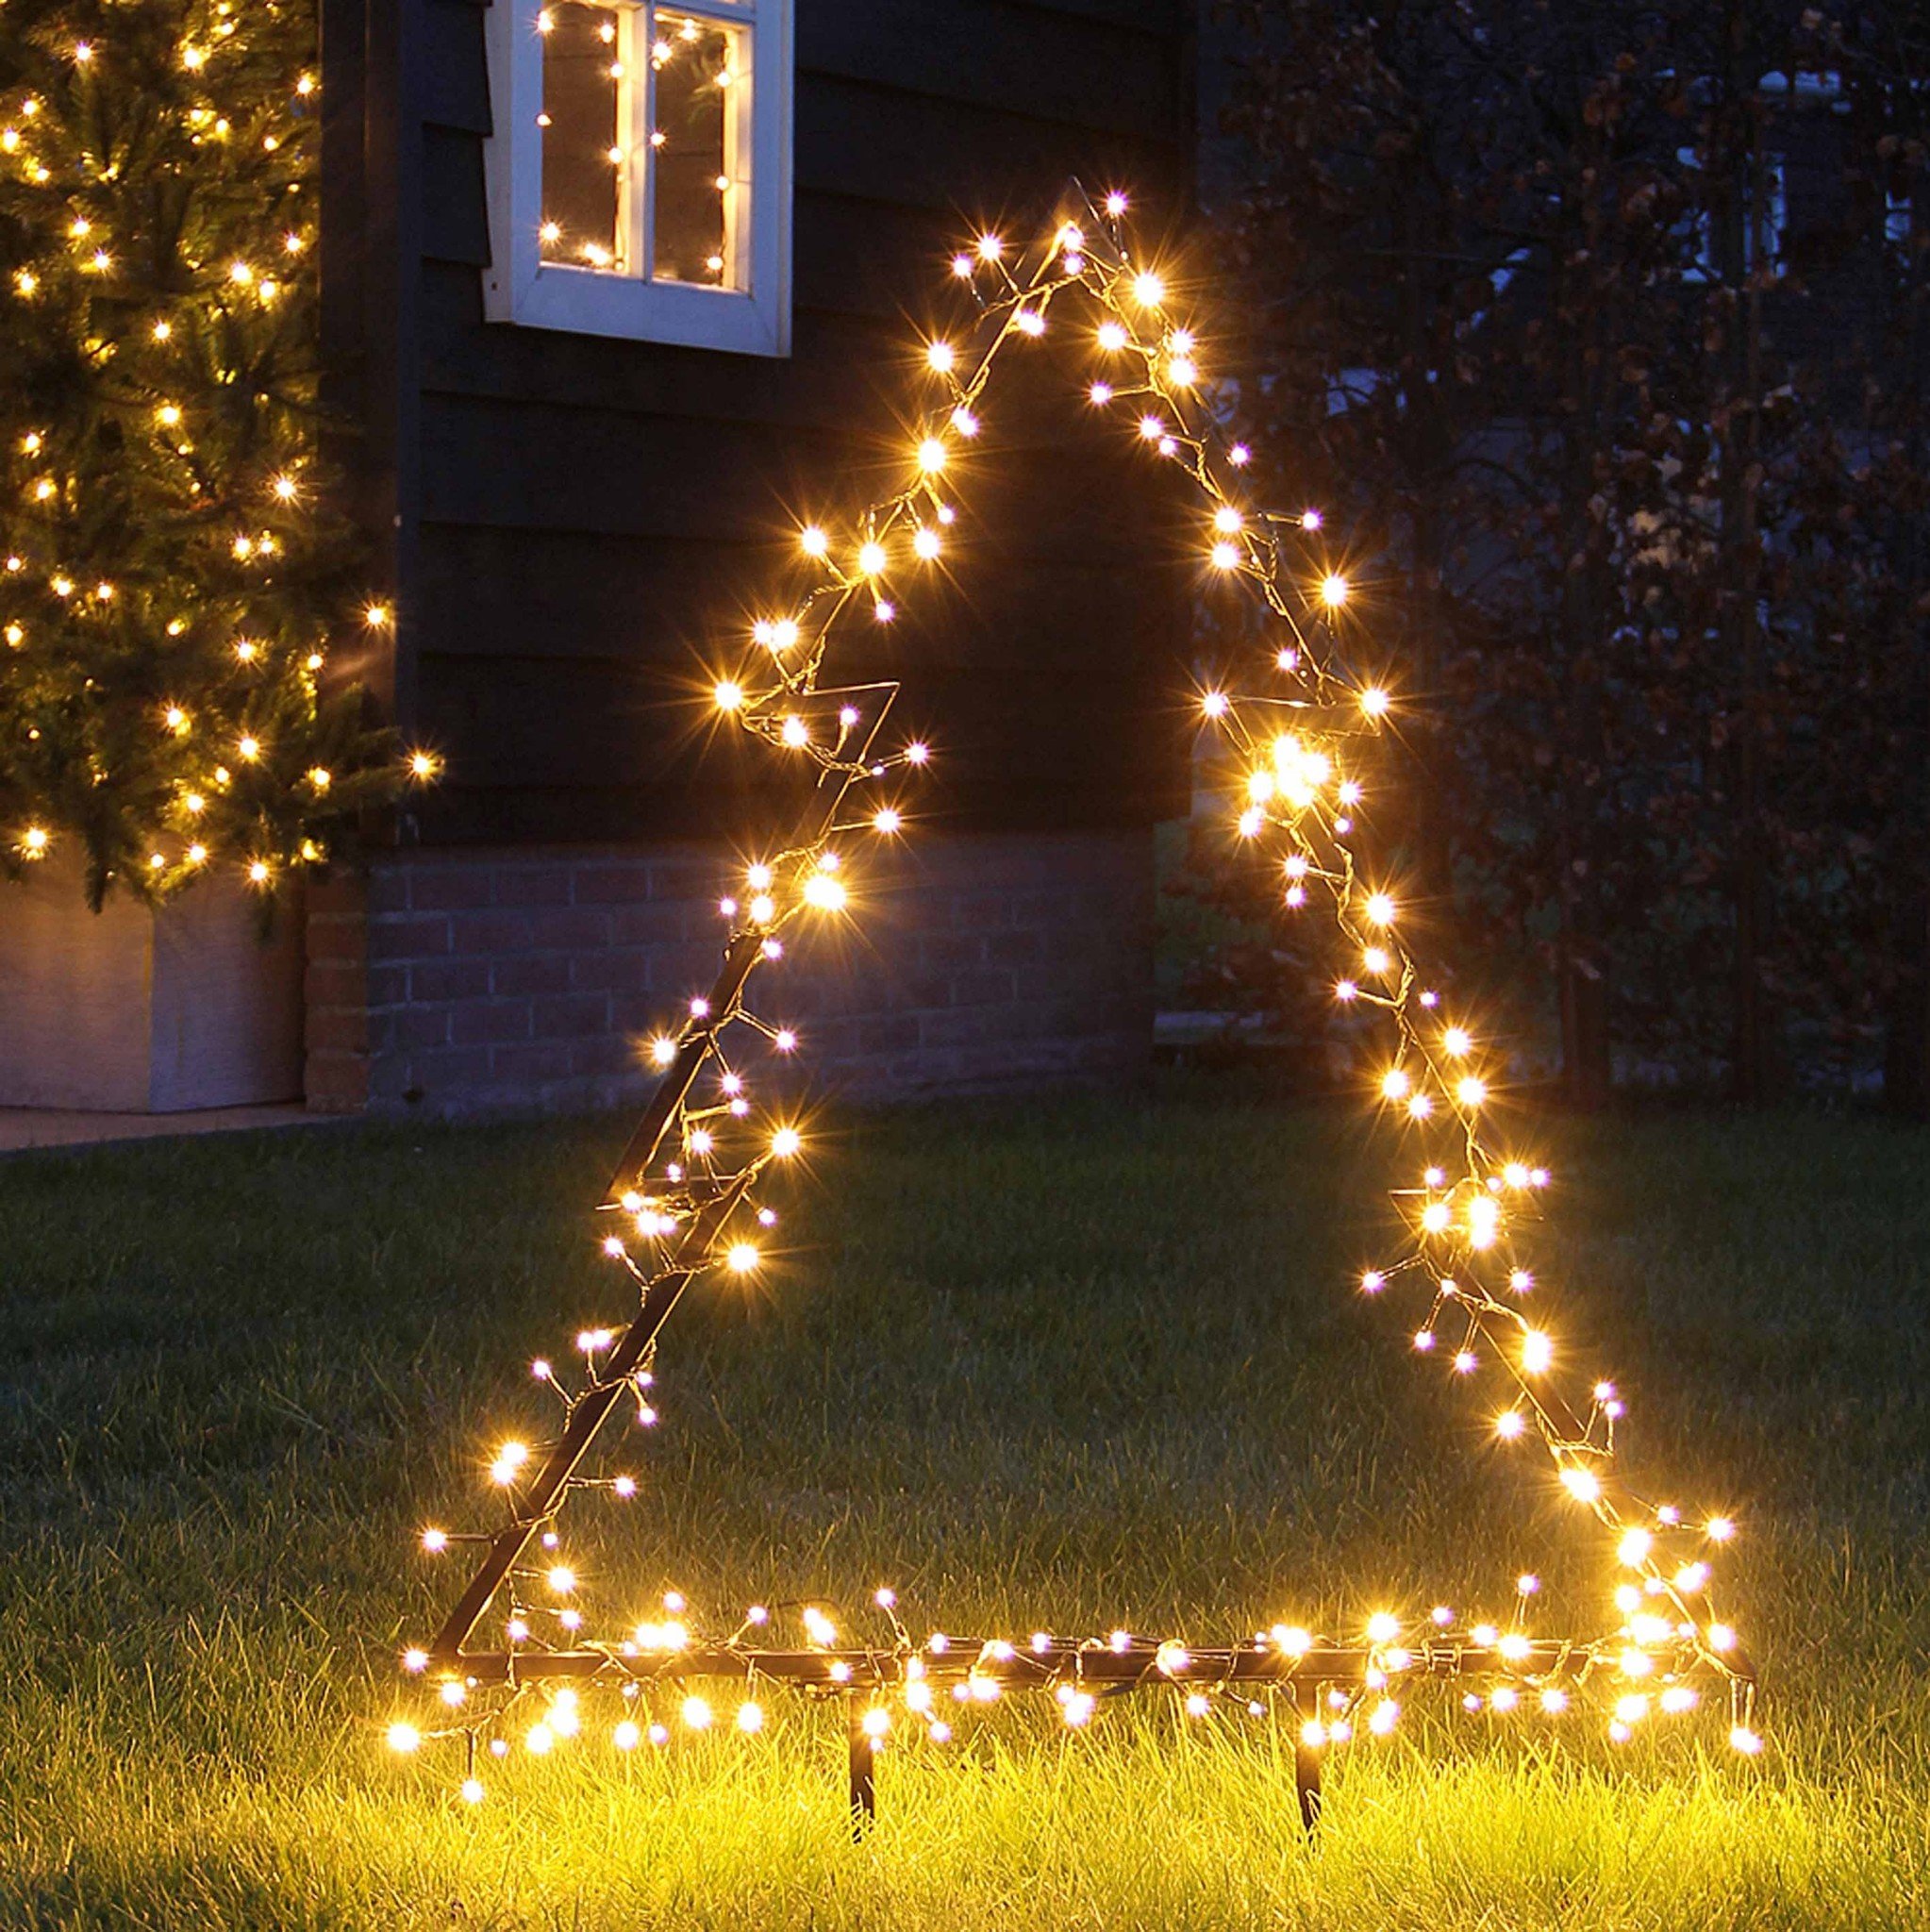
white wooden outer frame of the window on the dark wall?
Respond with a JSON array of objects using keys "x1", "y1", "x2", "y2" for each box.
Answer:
[{"x1": 483, "y1": 0, "x2": 794, "y2": 356}]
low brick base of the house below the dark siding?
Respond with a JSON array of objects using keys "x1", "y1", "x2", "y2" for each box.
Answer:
[{"x1": 308, "y1": 831, "x2": 1154, "y2": 1115}]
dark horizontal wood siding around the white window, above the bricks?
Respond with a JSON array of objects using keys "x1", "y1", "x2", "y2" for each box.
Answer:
[{"x1": 341, "y1": 0, "x2": 1192, "y2": 842}]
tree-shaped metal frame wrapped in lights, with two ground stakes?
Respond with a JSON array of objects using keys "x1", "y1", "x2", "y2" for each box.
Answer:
[{"x1": 408, "y1": 182, "x2": 1760, "y2": 1829}]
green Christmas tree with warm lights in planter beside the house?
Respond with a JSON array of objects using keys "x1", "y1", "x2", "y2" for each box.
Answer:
[{"x1": 0, "y1": 0, "x2": 433, "y2": 904}]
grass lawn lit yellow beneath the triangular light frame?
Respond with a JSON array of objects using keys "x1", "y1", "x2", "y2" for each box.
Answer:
[{"x1": 0, "y1": 1084, "x2": 1930, "y2": 1932}]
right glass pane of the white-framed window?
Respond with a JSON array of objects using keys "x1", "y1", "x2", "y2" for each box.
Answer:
[{"x1": 651, "y1": 11, "x2": 750, "y2": 288}]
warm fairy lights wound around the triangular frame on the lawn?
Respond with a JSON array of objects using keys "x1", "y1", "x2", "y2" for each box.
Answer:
[{"x1": 391, "y1": 192, "x2": 1762, "y2": 1801}]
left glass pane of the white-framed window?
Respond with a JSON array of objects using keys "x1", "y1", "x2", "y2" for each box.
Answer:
[{"x1": 543, "y1": 0, "x2": 622, "y2": 269}]
